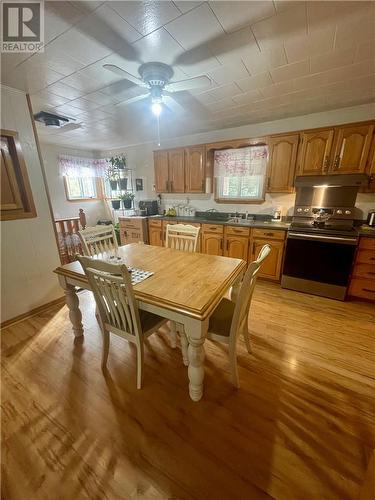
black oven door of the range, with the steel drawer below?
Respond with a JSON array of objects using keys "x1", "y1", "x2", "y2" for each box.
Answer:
[{"x1": 281, "y1": 231, "x2": 357, "y2": 300}]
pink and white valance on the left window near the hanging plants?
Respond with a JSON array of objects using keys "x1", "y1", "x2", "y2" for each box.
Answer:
[{"x1": 58, "y1": 155, "x2": 108, "y2": 177}]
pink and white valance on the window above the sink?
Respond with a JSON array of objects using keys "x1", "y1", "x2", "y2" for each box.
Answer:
[{"x1": 214, "y1": 146, "x2": 268, "y2": 177}]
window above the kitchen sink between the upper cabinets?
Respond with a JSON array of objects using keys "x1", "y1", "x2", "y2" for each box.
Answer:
[{"x1": 214, "y1": 146, "x2": 268, "y2": 203}]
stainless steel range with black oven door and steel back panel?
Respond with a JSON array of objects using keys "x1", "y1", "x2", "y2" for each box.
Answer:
[{"x1": 281, "y1": 174, "x2": 367, "y2": 300}]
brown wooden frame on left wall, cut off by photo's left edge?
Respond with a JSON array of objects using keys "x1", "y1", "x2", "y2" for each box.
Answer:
[{"x1": 0, "y1": 129, "x2": 37, "y2": 221}]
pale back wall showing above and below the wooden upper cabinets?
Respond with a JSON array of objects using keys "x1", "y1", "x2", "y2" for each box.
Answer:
[{"x1": 107, "y1": 104, "x2": 375, "y2": 215}]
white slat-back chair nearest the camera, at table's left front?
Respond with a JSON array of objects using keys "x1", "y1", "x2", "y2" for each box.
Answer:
[{"x1": 77, "y1": 255, "x2": 167, "y2": 389}]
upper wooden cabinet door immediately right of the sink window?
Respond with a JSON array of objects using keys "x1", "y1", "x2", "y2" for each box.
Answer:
[{"x1": 267, "y1": 134, "x2": 299, "y2": 193}]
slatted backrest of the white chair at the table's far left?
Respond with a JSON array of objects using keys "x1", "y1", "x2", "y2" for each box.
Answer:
[{"x1": 78, "y1": 224, "x2": 118, "y2": 256}]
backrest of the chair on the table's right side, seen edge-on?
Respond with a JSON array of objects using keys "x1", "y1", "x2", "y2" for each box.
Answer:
[{"x1": 230, "y1": 245, "x2": 271, "y2": 342}]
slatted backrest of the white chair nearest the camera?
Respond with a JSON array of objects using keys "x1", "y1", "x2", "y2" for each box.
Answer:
[{"x1": 77, "y1": 255, "x2": 142, "y2": 338}]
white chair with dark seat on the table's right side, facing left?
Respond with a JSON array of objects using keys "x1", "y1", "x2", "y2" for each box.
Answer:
[{"x1": 180, "y1": 245, "x2": 271, "y2": 387}]
